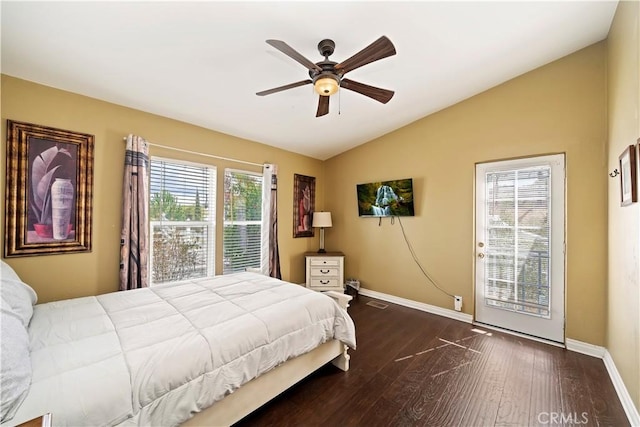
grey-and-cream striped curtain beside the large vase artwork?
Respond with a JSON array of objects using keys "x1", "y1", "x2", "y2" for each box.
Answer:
[{"x1": 120, "y1": 135, "x2": 149, "y2": 291}]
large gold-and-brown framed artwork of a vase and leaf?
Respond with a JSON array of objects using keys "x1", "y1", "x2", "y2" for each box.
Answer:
[{"x1": 4, "y1": 120, "x2": 94, "y2": 257}]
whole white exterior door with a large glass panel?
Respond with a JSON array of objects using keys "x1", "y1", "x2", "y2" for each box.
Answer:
[{"x1": 475, "y1": 154, "x2": 565, "y2": 343}]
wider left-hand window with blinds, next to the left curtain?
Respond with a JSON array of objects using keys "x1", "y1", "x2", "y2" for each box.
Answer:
[{"x1": 149, "y1": 158, "x2": 216, "y2": 285}]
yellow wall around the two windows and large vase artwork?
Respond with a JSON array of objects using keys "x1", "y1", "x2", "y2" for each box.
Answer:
[{"x1": 0, "y1": 75, "x2": 324, "y2": 302}]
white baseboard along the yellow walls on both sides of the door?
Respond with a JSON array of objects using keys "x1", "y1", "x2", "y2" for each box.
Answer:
[{"x1": 359, "y1": 294, "x2": 640, "y2": 427}]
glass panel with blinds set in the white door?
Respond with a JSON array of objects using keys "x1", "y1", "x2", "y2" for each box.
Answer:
[{"x1": 484, "y1": 166, "x2": 551, "y2": 318}]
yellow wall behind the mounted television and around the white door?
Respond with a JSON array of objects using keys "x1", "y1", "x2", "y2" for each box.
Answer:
[{"x1": 325, "y1": 42, "x2": 608, "y2": 345}]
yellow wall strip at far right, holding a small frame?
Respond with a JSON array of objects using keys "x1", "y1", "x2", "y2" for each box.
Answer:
[{"x1": 606, "y1": 1, "x2": 640, "y2": 408}]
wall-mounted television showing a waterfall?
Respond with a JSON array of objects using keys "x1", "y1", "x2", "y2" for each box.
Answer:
[{"x1": 356, "y1": 178, "x2": 414, "y2": 217}]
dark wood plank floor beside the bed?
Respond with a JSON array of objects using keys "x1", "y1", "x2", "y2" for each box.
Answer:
[{"x1": 236, "y1": 295, "x2": 629, "y2": 427}]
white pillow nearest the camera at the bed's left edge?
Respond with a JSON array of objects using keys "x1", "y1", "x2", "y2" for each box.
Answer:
[{"x1": 0, "y1": 297, "x2": 32, "y2": 423}]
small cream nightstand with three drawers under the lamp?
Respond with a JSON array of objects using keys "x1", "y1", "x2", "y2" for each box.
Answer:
[{"x1": 304, "y1": 252, "x2": 344, "y2": 292}]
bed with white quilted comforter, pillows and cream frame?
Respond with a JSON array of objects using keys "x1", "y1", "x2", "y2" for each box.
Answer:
[{"x1": 0, "y1": 261, "x2": 356, "y2": 426}]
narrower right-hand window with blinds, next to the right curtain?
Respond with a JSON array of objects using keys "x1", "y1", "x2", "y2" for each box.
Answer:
[{"x1": 222, "y1": 169, "x2": 262, "y2": 274}]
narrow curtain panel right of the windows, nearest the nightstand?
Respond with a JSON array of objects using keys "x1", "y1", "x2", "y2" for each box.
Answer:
[{"x1": 260, "y1": 164, "x2": 282, "y2": 279}]
